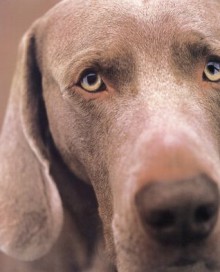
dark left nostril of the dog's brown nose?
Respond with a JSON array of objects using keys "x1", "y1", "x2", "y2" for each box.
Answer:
[{"x1": 146, "y1": 210, "x2": 176, "y2": 230}]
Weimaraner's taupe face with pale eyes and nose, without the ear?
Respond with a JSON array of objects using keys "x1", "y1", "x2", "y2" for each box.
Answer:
[{"x1": 2, "y1": 0, "x2": 220, "y2": 272}]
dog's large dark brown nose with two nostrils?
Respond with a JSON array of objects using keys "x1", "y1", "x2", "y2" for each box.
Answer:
[{"x1": 136, "y1": 175, "x2": 219, "y2": 246}]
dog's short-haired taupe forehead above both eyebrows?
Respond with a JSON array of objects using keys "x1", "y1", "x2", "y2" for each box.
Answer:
[{"x1": 41, "y1": 0, "x2": 220, "y2": 72}]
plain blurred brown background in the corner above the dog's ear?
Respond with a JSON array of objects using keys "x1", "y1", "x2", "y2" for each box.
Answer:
[{"x1": 0, "y1": 0, "x2": 59, "y2": 128}]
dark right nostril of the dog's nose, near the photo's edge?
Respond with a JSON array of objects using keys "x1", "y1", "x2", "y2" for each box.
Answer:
[{"x1": 195, "y1": 204, "x2": 217, "y2": 224}]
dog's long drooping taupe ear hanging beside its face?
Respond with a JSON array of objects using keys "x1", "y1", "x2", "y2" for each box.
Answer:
[{"x1": 0, "y1": 25, "x2": 63, "y2": 260}]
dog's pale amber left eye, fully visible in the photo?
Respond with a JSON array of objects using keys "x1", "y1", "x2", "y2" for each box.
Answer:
[{"x1": 79, "y1": 70, "x2": 106, "y2": 93}]
